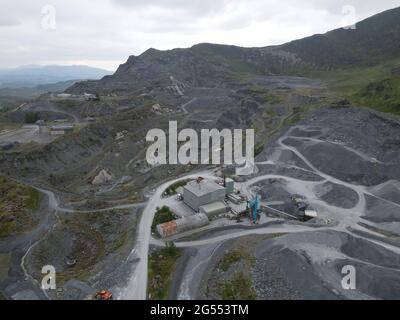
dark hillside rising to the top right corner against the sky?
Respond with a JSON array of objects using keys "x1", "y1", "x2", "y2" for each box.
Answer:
[{"x1": 280, "y1": 7, "x2": 400, "y2": 68}]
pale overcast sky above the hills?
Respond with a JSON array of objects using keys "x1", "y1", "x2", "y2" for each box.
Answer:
[{"x1": 0, "y1": 0, "x2": 399, "y2": 70}]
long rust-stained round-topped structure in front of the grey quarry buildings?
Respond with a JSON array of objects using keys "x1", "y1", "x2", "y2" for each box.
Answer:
[{"x1": 157, "y1": 213, "x2": 210, "y2": 238}]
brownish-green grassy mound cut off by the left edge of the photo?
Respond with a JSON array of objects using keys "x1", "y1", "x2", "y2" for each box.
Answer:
[{"x1": 0, "y1": 177, "x2": 41, "y2": 237}]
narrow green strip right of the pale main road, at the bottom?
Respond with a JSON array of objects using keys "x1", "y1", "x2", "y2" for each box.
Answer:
[{"x1": 148, "y1": 242, "x2": 181, "y2": 300}]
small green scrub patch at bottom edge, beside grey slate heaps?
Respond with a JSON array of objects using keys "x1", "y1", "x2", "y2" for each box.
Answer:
[{"x1": 218, "y1": 272, "x2": 257, "y2": 300}]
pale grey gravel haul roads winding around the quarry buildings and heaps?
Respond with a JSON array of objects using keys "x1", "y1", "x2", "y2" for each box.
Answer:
[{"x1": 118, "y1": 126, "x2": 400, "y2": 300}]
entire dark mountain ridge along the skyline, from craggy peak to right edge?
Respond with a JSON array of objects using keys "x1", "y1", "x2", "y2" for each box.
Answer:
[{"x1": 67, "y1": 7, "x2": 400, "y2": 95}]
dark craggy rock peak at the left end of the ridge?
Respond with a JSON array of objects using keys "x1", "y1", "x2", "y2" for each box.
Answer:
[{"x1": 67, "y1": 49, "x2": 227, "y2": 95}]
